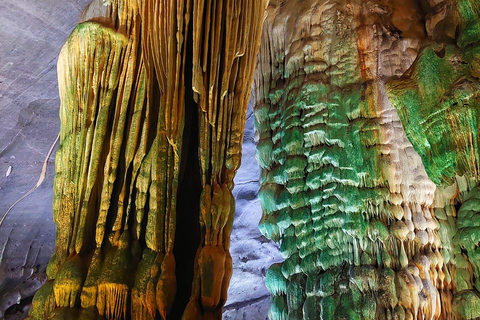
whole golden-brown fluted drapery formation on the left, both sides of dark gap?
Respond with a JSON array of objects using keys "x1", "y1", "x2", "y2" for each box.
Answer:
[{"x1": 30, "y1": 0, "x2": 265, "y2": 319}]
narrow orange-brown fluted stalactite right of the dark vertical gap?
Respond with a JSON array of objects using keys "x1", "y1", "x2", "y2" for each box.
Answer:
[{"x1": 183, "y1": 0, "x2": 267, "y2": 319}]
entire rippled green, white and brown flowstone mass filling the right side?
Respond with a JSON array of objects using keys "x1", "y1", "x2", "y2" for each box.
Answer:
[{"x1": 255, "y1": 0, "x2": 480, "y2": 320}]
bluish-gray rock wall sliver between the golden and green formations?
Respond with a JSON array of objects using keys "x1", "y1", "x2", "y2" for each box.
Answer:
[{"x1": 223, "y1": 103, "x2": 282, "y2": 320}]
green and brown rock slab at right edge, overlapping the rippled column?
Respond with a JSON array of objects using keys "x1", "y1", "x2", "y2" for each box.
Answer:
[{"x1": 388, "y1": 0, "x2": 480, "y2": 319}]
